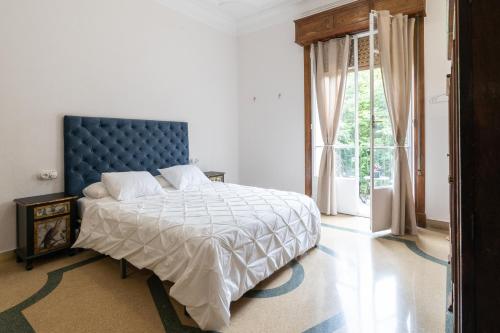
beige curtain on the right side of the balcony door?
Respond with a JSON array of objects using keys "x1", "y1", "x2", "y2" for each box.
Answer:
[{"x1": 377, "y1": 11, "x2": 417, "y2": 235}]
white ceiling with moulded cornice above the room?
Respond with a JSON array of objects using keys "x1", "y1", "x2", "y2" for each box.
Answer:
[{"x1": 157, "y1": 0, "x2": 354, "y2": 35}]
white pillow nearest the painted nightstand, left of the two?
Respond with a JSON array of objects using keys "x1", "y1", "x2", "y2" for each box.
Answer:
[{"x1": 101, "y1": 171, "x2": 165, "y2": 201}]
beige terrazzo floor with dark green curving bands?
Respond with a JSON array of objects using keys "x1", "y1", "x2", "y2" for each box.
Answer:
[{"x1": 0, "y1": 215, "x2": 450, "y2": 333}]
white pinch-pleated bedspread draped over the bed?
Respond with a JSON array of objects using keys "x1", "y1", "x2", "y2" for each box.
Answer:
[{"x1": 74, "y1": 183, "x2": 321, "y2": 330}]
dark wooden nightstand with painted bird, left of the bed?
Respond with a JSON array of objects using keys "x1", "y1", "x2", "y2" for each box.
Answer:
[{"x1": 14, "y1": 193, "x2": 78, "y2": 270}]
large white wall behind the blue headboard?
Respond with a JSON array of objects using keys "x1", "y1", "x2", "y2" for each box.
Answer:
[{"x1": 0, "y1": 0, "x2": 239, "y2": 252}]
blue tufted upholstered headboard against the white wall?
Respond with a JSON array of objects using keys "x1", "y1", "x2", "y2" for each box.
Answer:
[{"x1": 64, "y1": 116, "x2": 189, "y2": 195}]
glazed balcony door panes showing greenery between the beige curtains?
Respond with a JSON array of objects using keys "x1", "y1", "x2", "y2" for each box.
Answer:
[{"x1": 313, "y1": 33, "x2": 411, "y2": 210}]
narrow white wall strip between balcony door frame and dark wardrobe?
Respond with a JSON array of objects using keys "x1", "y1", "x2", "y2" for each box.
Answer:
[{"x1": 425, "y1": 0, "x2": 451, "y2": 222}]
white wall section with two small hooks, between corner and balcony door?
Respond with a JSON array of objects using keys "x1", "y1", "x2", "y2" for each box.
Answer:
[{"x1": 238, "y1": 21, "x2": 304, "y2": 193}]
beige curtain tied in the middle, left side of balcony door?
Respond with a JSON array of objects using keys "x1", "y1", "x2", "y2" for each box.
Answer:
[{"x1": 311, "y1": 36, "x2": 350, "y2": 215}]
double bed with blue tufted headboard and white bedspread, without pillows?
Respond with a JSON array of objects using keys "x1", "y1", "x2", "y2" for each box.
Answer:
[{"x1": 64, "y1": 116, "x2": 320, "y2": 330}]
